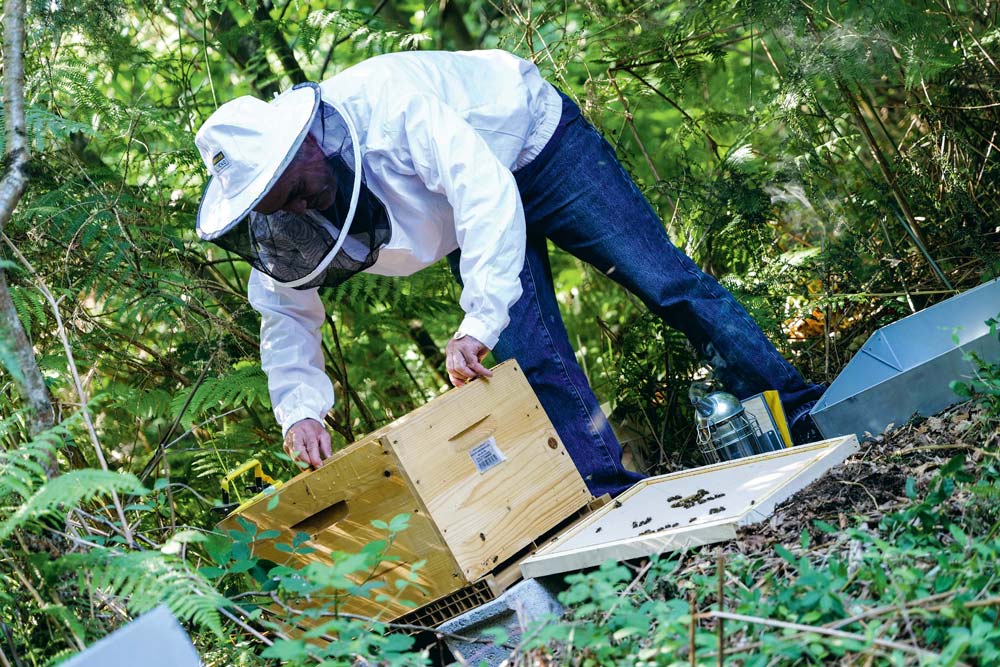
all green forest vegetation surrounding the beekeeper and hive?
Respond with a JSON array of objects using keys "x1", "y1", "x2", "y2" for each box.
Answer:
[{"x1": 0, "y1": 0, "x2": 1000, "y2": 667}]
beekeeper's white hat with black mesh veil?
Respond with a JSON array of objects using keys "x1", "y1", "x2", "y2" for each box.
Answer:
[{"x1": 195, "y1": 84, "x2": 390, "y2": 289}]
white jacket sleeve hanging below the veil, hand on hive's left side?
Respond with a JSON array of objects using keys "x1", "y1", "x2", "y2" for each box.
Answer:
[{"x1": 247, "y1": 269, "x2": 333, "y2": 434}]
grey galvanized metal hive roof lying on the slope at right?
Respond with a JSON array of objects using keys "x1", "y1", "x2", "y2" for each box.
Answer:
[{"x1": 810, "y1": 279, "x2": 1000, "y2": 438}]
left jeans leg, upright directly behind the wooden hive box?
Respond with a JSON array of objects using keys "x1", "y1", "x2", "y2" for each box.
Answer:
[{"x1": 448, "y1": 243, "x2": 643, "y2": 496}]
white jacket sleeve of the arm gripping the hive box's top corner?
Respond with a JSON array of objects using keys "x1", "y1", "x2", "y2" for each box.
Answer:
[{"x1": 387, "y1": 94, "x2": 525, "y2": 349}]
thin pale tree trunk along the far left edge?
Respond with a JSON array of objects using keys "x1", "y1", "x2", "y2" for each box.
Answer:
[{"x1": 0, "y1": 0, "x2": 55, "y2": 446}]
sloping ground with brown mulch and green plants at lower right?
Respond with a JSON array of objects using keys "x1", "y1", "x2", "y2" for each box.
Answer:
[{"x1": 511, "y1": 396, "x2": 1000, "y2": 666}]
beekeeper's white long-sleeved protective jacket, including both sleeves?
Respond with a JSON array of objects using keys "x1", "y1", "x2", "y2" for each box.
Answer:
[{"x1": 248, "y1": 51, "x2": 562, "y2": 432}]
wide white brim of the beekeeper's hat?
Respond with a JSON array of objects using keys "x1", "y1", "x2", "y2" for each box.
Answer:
[{"x1": 195, "y1": 83, "x2": 320, "y2": 241}]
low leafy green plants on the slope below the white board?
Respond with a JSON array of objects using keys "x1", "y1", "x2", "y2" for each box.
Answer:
[{"x1": 521, "y1": 446, "x2": 1000, "y2": 667}]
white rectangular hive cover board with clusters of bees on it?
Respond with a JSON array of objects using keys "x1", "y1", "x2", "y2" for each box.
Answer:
[{"x1": 521, "y1": 435, "x2": 858, "y2": 579}]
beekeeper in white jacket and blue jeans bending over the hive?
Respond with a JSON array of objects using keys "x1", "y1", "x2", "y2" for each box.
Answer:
[{"x1": 195, "y1": 51, "x2": 822, "y2": 495}]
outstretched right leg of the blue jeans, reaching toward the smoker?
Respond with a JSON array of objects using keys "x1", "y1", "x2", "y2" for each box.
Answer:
[{"x1": 515, "y1": 117, "x2": 823, "y2": 418}]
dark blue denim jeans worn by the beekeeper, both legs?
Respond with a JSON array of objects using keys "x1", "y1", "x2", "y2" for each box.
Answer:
[{"x1": 448, "y1": 99, "x2": 823, "y2": 496}]
